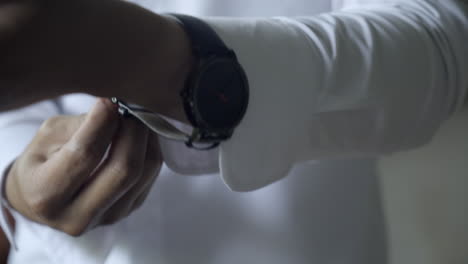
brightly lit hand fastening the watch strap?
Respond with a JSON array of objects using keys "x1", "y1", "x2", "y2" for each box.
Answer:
[{"x1": 6, "y1": 99, "x2": 162, "y2": 236}]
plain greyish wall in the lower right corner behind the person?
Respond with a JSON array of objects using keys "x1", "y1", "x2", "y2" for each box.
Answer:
[{"x1": 379, "y1": 109, "x2": 468, "y2": 264}]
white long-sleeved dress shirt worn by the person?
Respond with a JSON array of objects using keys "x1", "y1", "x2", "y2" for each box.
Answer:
[{"x1": 0, "y1": 0, "x2": 468, "y2": 264}]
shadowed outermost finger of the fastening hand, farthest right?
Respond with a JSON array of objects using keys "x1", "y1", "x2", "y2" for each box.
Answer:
[{"x1": 100, "y1": 134, "x2": 162, "y2": 225}]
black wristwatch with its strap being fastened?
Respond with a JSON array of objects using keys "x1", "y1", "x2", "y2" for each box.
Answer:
[{"x1": 112, "y1": 14, "x2": 249, "y2": 149}]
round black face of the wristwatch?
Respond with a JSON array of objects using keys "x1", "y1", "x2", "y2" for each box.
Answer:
[{"x1": 193, "y1": 58, "x2": 249, "y2": 130}]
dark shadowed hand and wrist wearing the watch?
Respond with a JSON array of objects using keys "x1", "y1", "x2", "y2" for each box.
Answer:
[{"x1": 0, "y1": 0, "x2": 192, "y2": 121}]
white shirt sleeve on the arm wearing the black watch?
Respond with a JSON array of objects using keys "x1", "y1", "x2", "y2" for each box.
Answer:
[{"x1": 178, "y1": 0, "x2": 468, "y2": 191}]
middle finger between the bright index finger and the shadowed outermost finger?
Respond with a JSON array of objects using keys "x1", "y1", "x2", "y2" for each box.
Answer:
[{"x1": 73, "y1": 118, "x2": 148, "y2": 224}]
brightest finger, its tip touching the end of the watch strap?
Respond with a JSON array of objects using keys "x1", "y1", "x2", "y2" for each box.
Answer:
[{"x1": 37, "y1": 99, "x2": 119, "y2": 203}]
